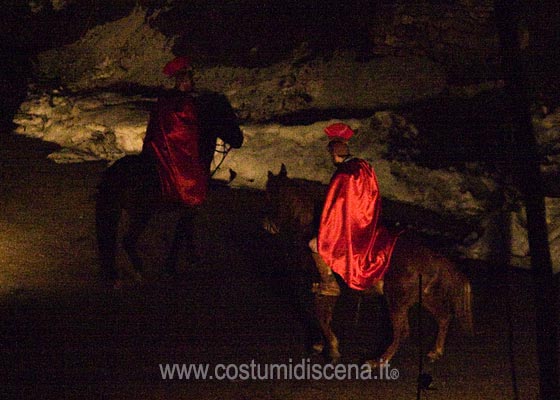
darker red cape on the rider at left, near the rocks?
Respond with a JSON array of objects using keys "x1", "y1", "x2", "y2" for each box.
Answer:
[{"x1": 142, "y1": 92, "x2": 208, "y2": 206}]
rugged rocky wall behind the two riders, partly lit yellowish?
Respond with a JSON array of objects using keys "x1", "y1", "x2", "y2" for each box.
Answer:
[{"x1": 9, "y1": 0, "x2": 560, "y2": 267}]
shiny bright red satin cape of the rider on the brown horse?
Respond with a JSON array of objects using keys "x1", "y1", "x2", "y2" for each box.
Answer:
[{"x1": 318, "y1": 158, "x2": 397, "y2": 290}]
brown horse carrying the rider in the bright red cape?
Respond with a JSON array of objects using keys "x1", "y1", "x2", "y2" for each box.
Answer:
[{"x1": 263, "y1": 164, "x2": 473, "y2": 366}]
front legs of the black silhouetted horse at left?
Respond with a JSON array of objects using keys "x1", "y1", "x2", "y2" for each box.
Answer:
[{"x1": 165, "y1": 208, "x2": 199, "y2": 275}]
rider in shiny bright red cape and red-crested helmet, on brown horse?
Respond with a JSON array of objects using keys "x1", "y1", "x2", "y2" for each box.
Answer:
[{"x1": 309, "y1": 123, "x2": 396, "y2": 296}]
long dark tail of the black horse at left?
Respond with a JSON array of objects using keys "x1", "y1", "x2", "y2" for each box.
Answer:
[{"x1": 95, "y1": 163, "x2": 121, "y2": 279}]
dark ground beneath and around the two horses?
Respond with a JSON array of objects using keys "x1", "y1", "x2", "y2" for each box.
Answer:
[{"x1": 0, "y1": 132, "x2": 548, "y2": 400}]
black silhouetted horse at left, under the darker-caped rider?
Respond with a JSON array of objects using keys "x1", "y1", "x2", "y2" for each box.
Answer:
[{"x1": 95, "y1": 92, "x2": 243, "y2": 281}]
